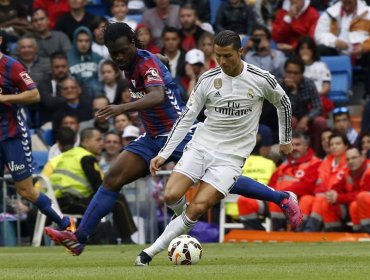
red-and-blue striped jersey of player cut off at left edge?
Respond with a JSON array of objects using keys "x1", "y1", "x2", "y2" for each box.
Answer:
[{"x1": 0, "y1": 54, "x2": 36, "y2": 141}]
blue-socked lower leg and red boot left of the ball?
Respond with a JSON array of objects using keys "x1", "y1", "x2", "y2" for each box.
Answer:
[{"x1": 45, "y1": 187, "x2": 119, "y2": 256}]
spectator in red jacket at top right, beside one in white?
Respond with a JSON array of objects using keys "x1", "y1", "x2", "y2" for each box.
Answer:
[{"x1": 271, "y1": 0, "x2": 319, "y2": 52}]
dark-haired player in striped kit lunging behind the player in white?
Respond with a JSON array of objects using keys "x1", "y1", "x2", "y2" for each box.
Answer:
[{"x1": 45, "y1": 23, "x2": 300, "y2": 255}]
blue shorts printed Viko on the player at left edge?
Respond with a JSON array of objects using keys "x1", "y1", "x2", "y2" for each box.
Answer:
[{"x1": 0, "y1": 135, "x2": 33, "y2": 182}]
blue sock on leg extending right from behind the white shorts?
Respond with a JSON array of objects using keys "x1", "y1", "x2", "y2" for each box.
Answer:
[{"x1": 230, "y1": 176, "x2": 289, "y2": 205}]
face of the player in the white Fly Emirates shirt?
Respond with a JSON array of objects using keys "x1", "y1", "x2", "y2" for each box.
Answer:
[{"x1": 215, "y1": 44, "x2": 243, "y2": 77}]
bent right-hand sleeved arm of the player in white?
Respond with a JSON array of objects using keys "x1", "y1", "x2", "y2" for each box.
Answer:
[{"x1": 262, "y1": 74, "x2": 292, "y2": 155}]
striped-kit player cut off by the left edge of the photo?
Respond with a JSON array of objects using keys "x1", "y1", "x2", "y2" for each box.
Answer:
[{"x1": 0, "y1": 30, "x2": 73, "y2": 230}]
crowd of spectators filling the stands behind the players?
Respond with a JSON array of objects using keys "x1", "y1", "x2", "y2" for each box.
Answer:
[{"x1": 0, "y1": 0, "x2": 370, "y2": 245}]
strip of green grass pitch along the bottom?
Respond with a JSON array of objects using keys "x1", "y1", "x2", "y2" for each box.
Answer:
[{"x1": 0, "y1": 243, "x2": 370, "y2": 280}]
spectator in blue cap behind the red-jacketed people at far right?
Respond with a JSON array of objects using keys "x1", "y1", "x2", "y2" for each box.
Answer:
[{"x1": 333, "y1": 107, "x2": 358, "y2": 146}]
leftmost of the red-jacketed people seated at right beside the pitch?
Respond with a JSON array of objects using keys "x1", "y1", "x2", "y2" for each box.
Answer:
[{"x1": 269, "y1": 132, "x2": 321, "y2": 231}]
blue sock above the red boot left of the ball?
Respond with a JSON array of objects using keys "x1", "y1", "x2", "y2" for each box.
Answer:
[{"x1": 75, "y1": 186, "x2": 119, "y2": 243}]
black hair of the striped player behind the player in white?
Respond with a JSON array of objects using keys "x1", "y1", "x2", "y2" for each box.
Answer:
[{"x1": 104, "y1": 22, "x2": 142, "y2": 48}]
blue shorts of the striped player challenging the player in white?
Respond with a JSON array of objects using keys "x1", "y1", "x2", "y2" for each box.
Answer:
[{"x1": 124, "y1": 132, "x2": 193, "y2": 173}]
